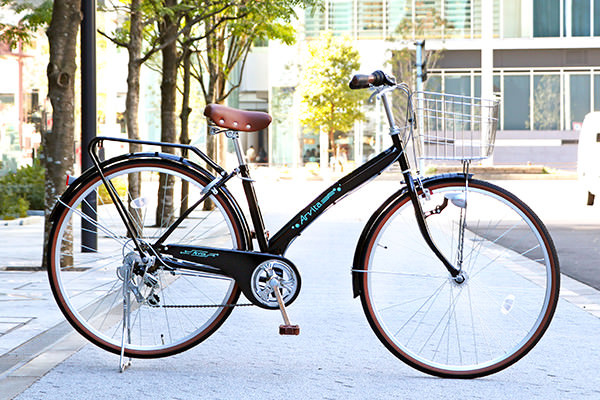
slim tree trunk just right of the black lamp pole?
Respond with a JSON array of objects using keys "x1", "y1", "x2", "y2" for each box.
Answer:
[{"x1": 125, "y1": 0, "x2": 143, "y2": 236}]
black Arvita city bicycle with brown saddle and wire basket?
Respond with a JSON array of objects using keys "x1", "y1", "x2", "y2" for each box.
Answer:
[{"x1": 47, "y1": 71, "x2": 560, "y2": 378}]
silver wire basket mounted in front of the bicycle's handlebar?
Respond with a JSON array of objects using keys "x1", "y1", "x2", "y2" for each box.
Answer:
[{"x1": 412, "y1": 92, "x2": 500, "y2": 160}]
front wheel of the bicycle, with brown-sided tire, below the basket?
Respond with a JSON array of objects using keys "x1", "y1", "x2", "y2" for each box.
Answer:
[{"x1": 355, "y1": 179, "x2": 560, "y2": 378}]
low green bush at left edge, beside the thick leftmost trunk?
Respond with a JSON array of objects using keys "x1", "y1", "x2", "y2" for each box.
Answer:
[{"x1": 0, "y1": 161, "x2": 45, "y2": 219}]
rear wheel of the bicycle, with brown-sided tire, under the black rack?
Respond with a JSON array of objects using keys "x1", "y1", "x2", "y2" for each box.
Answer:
[{"x1": 46, "y1": 158, "x2": 248, "y2": 358}]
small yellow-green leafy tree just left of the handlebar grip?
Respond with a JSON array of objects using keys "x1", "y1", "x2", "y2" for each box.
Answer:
[{"x1": 298, "y1": 32, "x2": 365, "y2": 167}]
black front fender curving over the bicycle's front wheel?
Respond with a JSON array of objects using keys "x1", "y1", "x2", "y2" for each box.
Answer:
[{"x1": 352, "y1": 173, "x2": 473, "y2": 297}]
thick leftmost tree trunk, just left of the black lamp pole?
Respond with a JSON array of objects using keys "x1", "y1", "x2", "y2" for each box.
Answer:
[{"x1": 42, "y1": 0, "x2": 81, "y2": 265}]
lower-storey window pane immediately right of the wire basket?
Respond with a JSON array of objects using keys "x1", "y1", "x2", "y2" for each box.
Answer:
[{"x1": 503, "y1": 75, "x2": 530, "y2": 130}]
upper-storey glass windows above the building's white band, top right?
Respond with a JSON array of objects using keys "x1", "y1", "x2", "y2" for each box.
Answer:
[{"x1": 305, "y1": 0, "x2": 600, "y2": 39}]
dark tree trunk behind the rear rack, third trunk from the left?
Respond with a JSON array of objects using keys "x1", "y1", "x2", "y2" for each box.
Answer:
[{"x1": 156, "y1": 0, "x2": 179, "y2": 226}]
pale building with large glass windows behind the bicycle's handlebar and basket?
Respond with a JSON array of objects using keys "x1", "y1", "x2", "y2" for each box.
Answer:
[{"x1": 262, "y1": 0, "x2": 600, "y2": 169}]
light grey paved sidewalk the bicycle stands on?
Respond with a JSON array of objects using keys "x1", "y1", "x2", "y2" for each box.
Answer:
[{"x1": 0, "y1": 181, "x2": 600, "y2": 400}]
